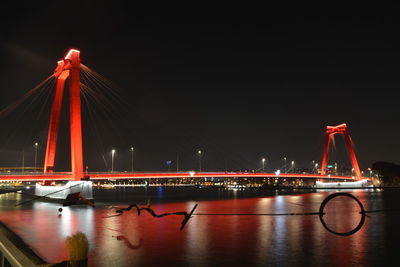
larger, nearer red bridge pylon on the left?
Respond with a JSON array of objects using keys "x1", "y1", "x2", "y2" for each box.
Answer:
[{"x1": 44, "y1": 49, "x2": 84, "y2": 181}]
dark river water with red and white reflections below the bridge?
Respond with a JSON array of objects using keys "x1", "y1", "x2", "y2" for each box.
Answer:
[{"x1": 0, "y1": 187, "x2": 400, "y2": 266}]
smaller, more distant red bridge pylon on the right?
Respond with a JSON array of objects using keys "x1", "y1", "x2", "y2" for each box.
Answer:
[{"x1": 321, "y1": 123, "x2": 362, "y2": 180}]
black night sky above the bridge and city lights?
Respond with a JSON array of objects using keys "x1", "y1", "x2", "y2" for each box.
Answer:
[{"x1": 0, "y1": 1, "x2": 400, "y2": 171}]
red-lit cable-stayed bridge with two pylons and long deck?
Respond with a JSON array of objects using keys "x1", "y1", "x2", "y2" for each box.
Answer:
[{"x1": 0, "y1": 49, "x2": 365, "y2": 183}]
